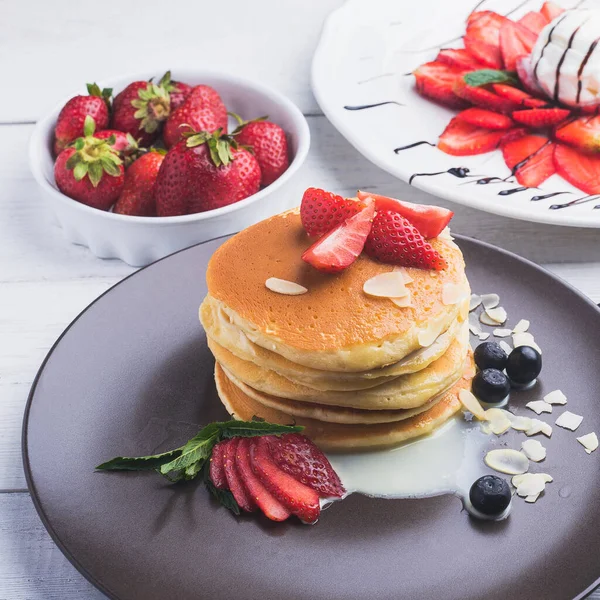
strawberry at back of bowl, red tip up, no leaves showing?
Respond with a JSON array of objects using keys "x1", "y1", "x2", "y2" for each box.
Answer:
[{"x1": 163, "y1": 85, "x2": 227, "y2": 148}]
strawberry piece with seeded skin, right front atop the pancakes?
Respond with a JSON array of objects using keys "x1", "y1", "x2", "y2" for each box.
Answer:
[{"x1": 365, "y1": 210, "x2": 448, "y2": 271}]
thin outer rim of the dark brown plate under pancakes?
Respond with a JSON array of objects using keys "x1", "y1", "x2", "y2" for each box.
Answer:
[{"x1": 21, "y1": 233, "x2": 600, "y2": 600}]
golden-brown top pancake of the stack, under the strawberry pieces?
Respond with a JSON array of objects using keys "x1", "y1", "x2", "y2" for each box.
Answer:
[{"x1": 204, "y1": 210, "x2": 469, "y2": 372}]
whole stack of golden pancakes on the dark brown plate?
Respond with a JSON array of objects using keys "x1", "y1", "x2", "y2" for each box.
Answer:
[{"x1": 200, "y1": 211, "x2": 474, "y2": 451}]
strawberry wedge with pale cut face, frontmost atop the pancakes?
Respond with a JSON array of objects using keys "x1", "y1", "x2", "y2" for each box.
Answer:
[{"x1": 302, "y1": 202, "x2": 375, "y2": 273}]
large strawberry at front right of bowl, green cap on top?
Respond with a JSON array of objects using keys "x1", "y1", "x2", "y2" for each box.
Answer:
[{"x1": 154, "y1": 127, "x2": 261, "y2": 217}]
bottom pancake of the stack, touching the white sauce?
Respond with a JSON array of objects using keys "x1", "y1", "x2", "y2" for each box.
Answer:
[{"x1": 215, "y1": 353, "x2": 474, "y2": 452}]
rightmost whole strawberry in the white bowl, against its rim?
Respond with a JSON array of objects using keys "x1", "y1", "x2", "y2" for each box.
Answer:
[{"x1": 232, "y1": 113, "x2": 290, "y2": 187}]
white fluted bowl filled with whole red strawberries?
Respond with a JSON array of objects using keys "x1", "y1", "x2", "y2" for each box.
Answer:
[{"x1": 30, "y1": 70, "x2": 310, "y2": 266}]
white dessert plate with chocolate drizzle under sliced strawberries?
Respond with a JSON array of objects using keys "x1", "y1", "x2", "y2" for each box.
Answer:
[{"x1": 312, "y1": 0, "x2": 600, "y2": 227}]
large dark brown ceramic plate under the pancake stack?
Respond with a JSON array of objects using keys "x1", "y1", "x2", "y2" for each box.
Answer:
[{"x1": 23, "y1": 238, "x2": 600, "y2": 600}]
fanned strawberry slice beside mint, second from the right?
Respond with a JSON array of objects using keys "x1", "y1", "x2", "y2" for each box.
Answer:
[{"x1": 250, "y1": 436, "x2": 321, "y2": 523}]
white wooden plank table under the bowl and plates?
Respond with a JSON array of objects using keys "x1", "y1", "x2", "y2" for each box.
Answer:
[{"x1": 0, "y1": 0, "x2": 600, "y2": 600}]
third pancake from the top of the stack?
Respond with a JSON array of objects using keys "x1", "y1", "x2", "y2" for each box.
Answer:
[{"x1": 207, "y1": 330, "x2": 469, "y2": 410}]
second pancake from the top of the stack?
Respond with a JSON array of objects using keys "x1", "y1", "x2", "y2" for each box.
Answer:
[{"x1": 200, "y1": 301, "x2": 468, "y2": 391}]
